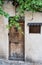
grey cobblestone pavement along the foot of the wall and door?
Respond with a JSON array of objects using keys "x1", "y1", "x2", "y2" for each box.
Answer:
[{"x1": 0, "y1": 59, "x2": 42, "y2": 65}]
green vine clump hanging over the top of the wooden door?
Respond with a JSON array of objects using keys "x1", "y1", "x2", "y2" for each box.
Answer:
[{"x1": 8, "y1": 15, "x2": 20, "y2": 28}]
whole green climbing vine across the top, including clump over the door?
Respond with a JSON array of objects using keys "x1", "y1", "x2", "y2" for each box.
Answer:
[{"x1": 0, "y1": 0, "x2": 42, "y2": 28}]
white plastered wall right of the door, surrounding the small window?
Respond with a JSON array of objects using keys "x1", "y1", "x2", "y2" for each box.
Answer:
[{"x1": 25, "y1": 12, "x2": 42, "y2": 62}]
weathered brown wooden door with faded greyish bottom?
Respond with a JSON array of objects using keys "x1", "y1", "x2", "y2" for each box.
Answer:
[{"x1": 9, "y1": 17, "x2": 24, "y2": 60}]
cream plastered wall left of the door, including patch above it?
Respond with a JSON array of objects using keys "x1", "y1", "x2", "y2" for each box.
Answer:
[{"x1": 0, "y1": 2, "x2": 15, "y2": 59}]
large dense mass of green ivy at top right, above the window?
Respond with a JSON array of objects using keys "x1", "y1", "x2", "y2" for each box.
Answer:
[{"x1": 17, "y1": 0, "x2": 42, "y2": 12}]
